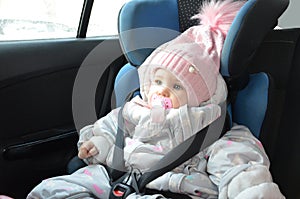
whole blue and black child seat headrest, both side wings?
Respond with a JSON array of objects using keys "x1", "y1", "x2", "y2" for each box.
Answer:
[{"x1": 118, "y1": 0, "x2": 289, "y2": 77}]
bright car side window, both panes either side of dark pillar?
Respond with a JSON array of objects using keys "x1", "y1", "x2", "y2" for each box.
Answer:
[{"x1": 0, "y1": 0, "x2": 125, "y2": 41}]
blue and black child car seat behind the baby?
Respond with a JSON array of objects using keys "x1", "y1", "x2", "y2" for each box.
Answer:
[{"x1": 115, "y1": 0, "x2": 289, "y2": 196}]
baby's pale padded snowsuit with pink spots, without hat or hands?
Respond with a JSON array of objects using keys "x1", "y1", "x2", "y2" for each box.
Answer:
[{"x1": 27, "y1": 75, "x2": 285, "y2": 199}]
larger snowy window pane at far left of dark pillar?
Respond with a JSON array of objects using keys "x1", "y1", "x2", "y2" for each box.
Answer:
[{"x1": 0, "y1": 0, "x2": 84, "y2": 41}]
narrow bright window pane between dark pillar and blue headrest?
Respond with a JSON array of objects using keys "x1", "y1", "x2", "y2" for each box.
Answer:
[{"x1": 86, "y1": 0, "x2": 128, "y2": 37}]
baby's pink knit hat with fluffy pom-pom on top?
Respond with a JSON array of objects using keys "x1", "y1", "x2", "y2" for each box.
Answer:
[{"x1": 139, "y1": 0, "x2": 245, "y2": 106}]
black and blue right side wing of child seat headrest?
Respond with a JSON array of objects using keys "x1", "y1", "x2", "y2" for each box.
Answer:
[{"x1": 220, "y1": 0, "x2": 289, "y2": 77}]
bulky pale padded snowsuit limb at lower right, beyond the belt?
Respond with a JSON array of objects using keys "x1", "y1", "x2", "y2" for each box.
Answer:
[{"x1": 207, "y1": 125, "x2": 285, "y2": 199}]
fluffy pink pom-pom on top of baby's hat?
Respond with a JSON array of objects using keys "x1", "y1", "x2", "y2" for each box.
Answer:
[{"x1": 192, "y1": 0, "x2": 245, "y2": 35}]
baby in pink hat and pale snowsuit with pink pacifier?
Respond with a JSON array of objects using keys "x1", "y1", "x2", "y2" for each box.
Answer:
[{"x1": 27, "y1": 0, "x2": 284, "y2": 199}]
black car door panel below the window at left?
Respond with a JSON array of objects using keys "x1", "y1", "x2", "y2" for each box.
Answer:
[{"x1": 0, "y1": 38, "x2": 125, "y2": 198}]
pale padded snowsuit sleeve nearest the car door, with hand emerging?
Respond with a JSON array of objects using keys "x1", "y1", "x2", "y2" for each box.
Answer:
[{"x1": 77, "y1": 108, "x2": 120, "y2": 164}]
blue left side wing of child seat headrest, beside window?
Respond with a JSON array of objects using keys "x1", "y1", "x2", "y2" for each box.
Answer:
[{"x1": 118, "y1": 0, "x2": 180, "y2": 66}]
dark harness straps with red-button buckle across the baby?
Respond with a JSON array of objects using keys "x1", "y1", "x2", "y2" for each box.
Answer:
[{"x1": 110, "y1": 102, "x2": 226, "y2": 199}]
